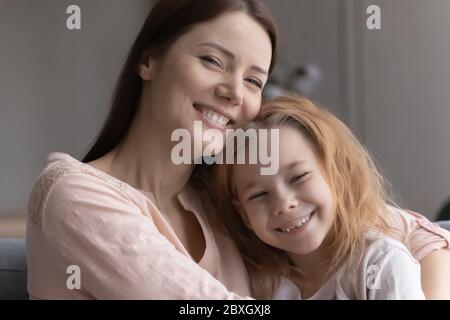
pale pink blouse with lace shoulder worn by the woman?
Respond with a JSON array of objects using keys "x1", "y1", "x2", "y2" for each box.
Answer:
[{"x1": 27, "y1": 153, "x2": 250, "y2": 299}]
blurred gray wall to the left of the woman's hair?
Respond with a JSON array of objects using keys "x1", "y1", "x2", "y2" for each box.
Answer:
[{"x1": 0, "y1": 0, "x2": 152, "y2": 214}]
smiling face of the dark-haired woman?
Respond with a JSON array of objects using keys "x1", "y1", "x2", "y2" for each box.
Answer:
[{"x1": 140, "y1": 12, "x2": 272, "y2": 157}]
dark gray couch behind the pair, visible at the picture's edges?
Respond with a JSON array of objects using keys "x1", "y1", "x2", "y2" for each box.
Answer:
[{"x1": 0, "y1": 220, "x2": 450, "y2": 300}]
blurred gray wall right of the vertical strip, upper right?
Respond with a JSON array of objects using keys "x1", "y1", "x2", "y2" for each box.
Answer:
[{"x1": 360, "y1": 0, "x2": 450, "y2": 217}]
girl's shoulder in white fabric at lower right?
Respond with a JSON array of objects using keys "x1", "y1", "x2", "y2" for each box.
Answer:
[{"x1": 336, "y1": 230, "x2": 423, "y2": 300}]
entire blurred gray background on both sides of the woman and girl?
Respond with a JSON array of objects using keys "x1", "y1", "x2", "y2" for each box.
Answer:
[{"x1": 0, "y1": 0, "x2": 450, "y2": 237}]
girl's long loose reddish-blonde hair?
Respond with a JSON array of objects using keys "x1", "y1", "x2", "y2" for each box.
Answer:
[{"x1": 211, "y1": 96, "x2": 396, "y2": 298}]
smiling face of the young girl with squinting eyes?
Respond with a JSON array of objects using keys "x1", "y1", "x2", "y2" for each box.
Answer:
[{"x1": 233, "y1": 127, "x2": 335, "y2": 255}]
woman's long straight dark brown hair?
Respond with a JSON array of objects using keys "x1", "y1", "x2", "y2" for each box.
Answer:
[{"x1": 83, "y1": 0, "x2": 278, "y2": 163}]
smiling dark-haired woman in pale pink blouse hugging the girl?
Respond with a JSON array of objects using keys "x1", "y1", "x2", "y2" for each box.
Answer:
[{"x1": 27, "y1": 0, "x2": 450, "y2": 299}]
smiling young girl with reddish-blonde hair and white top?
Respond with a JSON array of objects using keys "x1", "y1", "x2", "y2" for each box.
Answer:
[{"x1": 214, "y1": 96, "x2": 424, "y2": 299}]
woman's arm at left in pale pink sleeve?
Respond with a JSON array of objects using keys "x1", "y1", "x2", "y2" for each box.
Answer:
[{"x1": 37, "y1": 173, "x2": 250, "y2": 299}]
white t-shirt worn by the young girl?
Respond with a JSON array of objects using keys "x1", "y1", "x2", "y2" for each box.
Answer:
[{"x1": 273, "y1": 231, "x2": 425, "y2": 300}]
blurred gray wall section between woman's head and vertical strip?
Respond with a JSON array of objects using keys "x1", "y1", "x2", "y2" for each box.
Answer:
[{"x1": 265, "y1": 0, "x2": 344, "y2": 116}]
